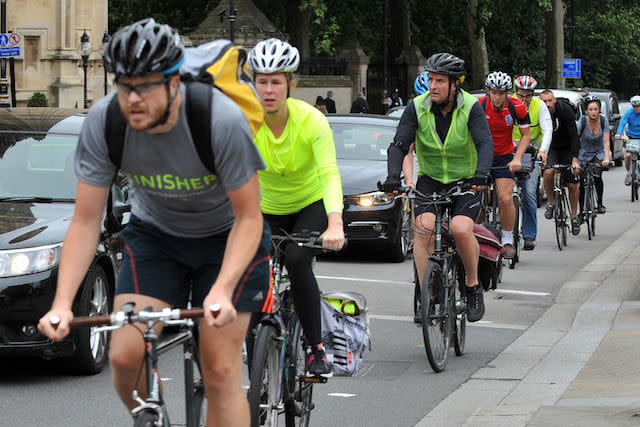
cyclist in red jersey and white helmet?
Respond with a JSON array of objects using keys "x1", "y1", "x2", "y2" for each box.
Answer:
[{"x1": 479, "y1": 71, "x2": 531, "y2": 259}]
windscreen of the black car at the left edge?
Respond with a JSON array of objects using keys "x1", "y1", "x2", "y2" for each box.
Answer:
[{"x1": 0, "y1": 131, "x2": 78, "y2": 201}]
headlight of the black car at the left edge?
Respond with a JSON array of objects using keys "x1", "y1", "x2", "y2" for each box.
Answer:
[{"x1": 0, "y1": 243, "x2": 62, "y2": 277}]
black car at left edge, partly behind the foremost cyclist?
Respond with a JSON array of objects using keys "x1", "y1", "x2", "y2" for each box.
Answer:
[{"x1": 0, "y1": 109, "x2": 128, "y2": 374}]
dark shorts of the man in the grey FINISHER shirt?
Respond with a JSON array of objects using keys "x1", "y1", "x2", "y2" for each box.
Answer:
[{"x1": 116, "y1": 215, "x2": 273, "y2": 312}]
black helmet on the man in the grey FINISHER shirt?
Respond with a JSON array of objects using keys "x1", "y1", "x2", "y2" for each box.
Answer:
[{"x1": 104, "y1": 18, "x2": 184, "y2": 78}]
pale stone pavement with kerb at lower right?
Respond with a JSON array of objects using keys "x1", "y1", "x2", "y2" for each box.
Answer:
[{"x1": 416, "y1": 216, "x2": 640, "y2": 427}]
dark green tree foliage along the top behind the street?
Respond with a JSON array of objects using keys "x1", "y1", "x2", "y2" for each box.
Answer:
[{"x1": 109, "y1": 0, "x2": 640, "y2": 97}]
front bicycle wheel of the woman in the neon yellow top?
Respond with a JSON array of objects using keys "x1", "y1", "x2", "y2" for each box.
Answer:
[{"x1": 247, "y1": 324, "x2": 280, "y2": 427}]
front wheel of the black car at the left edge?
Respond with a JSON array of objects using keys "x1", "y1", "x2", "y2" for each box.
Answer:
[{"x1": 71, "y1": 265, "x2": 113, "y2": 375}]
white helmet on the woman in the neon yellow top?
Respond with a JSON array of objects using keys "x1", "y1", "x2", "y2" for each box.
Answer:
[{"x1": 247, "y1": 38, "x2": 300, "y2": 74}]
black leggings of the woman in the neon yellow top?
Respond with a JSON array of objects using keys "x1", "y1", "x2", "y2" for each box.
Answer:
[{"x1": 252, "y1": 200, "x2": 327, "y2": 346}]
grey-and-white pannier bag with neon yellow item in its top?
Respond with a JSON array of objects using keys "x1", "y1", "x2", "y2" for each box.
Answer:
[{"x1": 320, "y1": 292, "x2": 371, "y2": 376}]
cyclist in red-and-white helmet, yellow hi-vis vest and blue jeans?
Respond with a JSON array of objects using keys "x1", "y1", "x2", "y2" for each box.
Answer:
[{"x1": 513, "y1": 76, "x2": 553, "y2": 251}]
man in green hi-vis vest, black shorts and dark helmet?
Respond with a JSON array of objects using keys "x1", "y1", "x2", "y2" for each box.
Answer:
[{"x1": 383, "y1": 53, "x2": 493, "y2": 322}]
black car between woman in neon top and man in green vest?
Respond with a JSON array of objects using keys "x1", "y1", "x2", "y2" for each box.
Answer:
[{"x1": 327, "y1": 114, "x2": 412, "y2": 262}]
